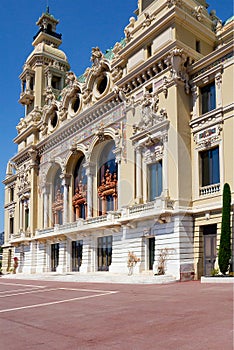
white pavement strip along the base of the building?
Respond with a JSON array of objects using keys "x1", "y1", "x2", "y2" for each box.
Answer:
[{"x1": 2, "y1": 272, "x2": 176, "y2": 284}]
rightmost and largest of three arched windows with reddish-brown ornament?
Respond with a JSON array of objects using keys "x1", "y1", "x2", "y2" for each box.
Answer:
[{"x1": 98, "y1": 140, "x2": 118, "y2": 215}]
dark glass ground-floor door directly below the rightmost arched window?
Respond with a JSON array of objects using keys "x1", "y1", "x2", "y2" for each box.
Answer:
[{"x1": 98, "y1": 236, "x2": 112, "y2": 271}]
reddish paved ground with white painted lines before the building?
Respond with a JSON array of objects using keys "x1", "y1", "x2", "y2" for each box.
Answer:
[{"x1": 0, "y1": 278, "x2": 233, "y2": 350}]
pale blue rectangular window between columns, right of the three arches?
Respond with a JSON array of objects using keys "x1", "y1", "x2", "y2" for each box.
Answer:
[{"x1": 148, "y1": 160, "x2": 162, "y2": 201}]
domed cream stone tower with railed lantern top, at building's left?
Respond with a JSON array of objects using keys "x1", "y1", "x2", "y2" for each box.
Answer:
[{"x1": 19, "y1": 7, "x2": 70, "y2": 116}]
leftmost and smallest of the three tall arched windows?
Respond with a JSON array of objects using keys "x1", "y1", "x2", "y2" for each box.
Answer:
[{"x1": 52, "y1": 169, "x2": 63, "y2": 225}]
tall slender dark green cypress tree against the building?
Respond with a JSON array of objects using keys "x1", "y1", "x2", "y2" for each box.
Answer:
[{"x1": 218, "y1": 183, "x2": 231, "y2": 274}]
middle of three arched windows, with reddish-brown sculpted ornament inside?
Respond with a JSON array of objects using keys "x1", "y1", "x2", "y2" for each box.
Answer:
[{"x1": 72, "y1": 156, "x2": 87, "y2": 220}]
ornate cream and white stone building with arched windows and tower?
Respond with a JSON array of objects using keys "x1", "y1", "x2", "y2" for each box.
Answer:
[{"x1": 3, "y1": 0, "x2": 234, "y2": 280}]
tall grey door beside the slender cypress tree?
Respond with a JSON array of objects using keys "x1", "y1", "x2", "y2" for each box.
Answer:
[{"x1": 203, "y1": 225, "x2": 217, "y2": 276}]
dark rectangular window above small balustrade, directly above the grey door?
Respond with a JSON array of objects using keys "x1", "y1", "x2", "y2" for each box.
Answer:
[{"x1": 200, "y1": 147, "x2": 220, "y2": 186}]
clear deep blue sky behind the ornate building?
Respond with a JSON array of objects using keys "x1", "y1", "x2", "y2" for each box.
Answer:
[{"x1": 0, "y1": 0, "x2": 233, "y2": 232}]
